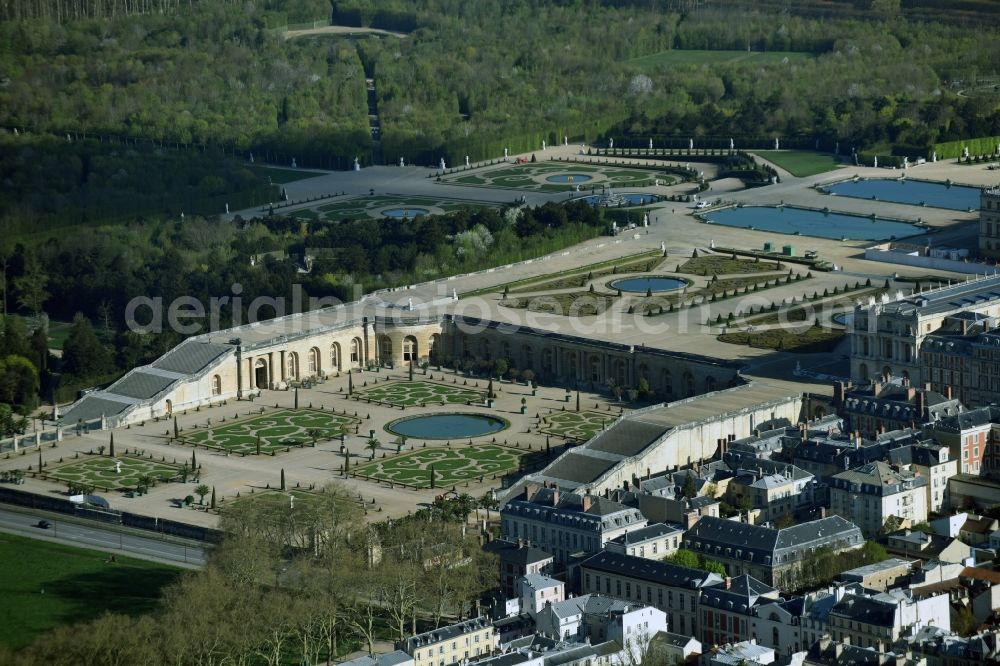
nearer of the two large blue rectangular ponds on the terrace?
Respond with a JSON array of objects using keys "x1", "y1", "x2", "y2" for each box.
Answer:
[{"x1": 701, "y1": 206, "x2": 925, "y2": 240}]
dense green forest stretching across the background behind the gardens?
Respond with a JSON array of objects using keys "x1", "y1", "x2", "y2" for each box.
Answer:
[{"x1": 0, "y1": 0, "x2": 1000, "y2": 168}]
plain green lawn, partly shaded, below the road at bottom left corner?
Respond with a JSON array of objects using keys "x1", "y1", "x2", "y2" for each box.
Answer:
[{"x1": 0, "y1": 534, "x2": 181, "y2": 649}]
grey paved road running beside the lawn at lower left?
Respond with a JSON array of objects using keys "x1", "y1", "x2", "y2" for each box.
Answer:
[{"x1": 0, "y1": 509, "x2": 206, "y2": 569}]
